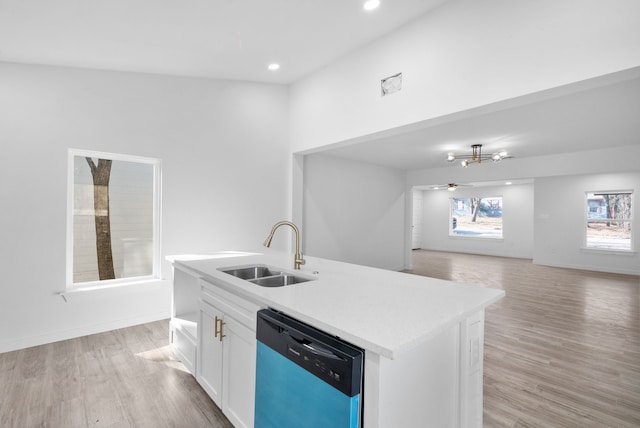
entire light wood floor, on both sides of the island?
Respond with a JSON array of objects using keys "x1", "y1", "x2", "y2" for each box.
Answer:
[{"x1": 0, "y1": 250, "x2": 640, "y2": 428}]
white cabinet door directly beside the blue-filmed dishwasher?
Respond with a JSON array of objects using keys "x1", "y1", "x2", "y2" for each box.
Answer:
[{"x1": 222, "y1": 315, "x2": 256, "y2": 428}]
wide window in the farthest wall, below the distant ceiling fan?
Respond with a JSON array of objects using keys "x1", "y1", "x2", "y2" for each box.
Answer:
[{"x1": 449, "y1": 196, "x2": 502, "y2": 238}]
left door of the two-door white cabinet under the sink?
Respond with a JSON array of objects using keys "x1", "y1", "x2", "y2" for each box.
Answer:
[{"x1": 196, "y1": 302, "x2": 225, "y2": 407}]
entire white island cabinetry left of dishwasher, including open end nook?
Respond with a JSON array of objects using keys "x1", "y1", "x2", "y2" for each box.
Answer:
[{"x1": 169, "y1": 265, "x2": 260, "y2": 428}]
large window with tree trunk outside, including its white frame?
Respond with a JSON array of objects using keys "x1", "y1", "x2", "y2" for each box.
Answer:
[{"x1": 67, "y1": 150, "x2": 160, "y2": 287}]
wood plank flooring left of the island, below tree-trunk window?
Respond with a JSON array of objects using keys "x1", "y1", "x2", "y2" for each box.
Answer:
[{"x1": 0, "y1": 321, "x2": 232, "y2": 428}]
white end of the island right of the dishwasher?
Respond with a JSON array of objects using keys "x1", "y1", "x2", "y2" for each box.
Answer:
[{"x1": 363, "y1": 310, "x2": 484, "y2": 428}]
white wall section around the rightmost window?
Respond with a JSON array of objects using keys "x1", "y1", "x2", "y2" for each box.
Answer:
[{"x1": 533, "y1": 171, "x2": 640, "y2": 275}]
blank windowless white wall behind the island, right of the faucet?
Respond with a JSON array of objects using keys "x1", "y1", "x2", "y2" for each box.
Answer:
[{"x1": 303, "y1": 155, "x2": 405, "y2": 270}]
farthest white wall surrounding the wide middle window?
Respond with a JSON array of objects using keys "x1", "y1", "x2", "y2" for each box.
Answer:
[{"x1": 421, "y1": 184, "x2": 534, "y2": 259}]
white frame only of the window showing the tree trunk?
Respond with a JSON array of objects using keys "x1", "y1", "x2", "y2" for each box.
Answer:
[{"x1": 66, "y1": 148, "x2": 162, "y2": 291}]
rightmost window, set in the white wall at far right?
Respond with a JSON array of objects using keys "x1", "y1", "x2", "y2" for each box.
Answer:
[{"x1": 585, "y1": 191, "x2": 632, "y2": 251}]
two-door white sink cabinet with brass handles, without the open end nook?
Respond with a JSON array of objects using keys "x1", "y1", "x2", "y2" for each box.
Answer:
[{"x1": 196, "y1": 280, "x2": 259, "y2": 427}]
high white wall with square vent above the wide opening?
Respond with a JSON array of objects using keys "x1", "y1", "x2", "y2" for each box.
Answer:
[{"x1": 291, "y1": 0, "x2": 640, "y2": 152}]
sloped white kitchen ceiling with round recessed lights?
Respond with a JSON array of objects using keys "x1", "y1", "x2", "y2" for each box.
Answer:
[{"x1": 0, "y1": 0, "x2": 447, "y2": 84}]
